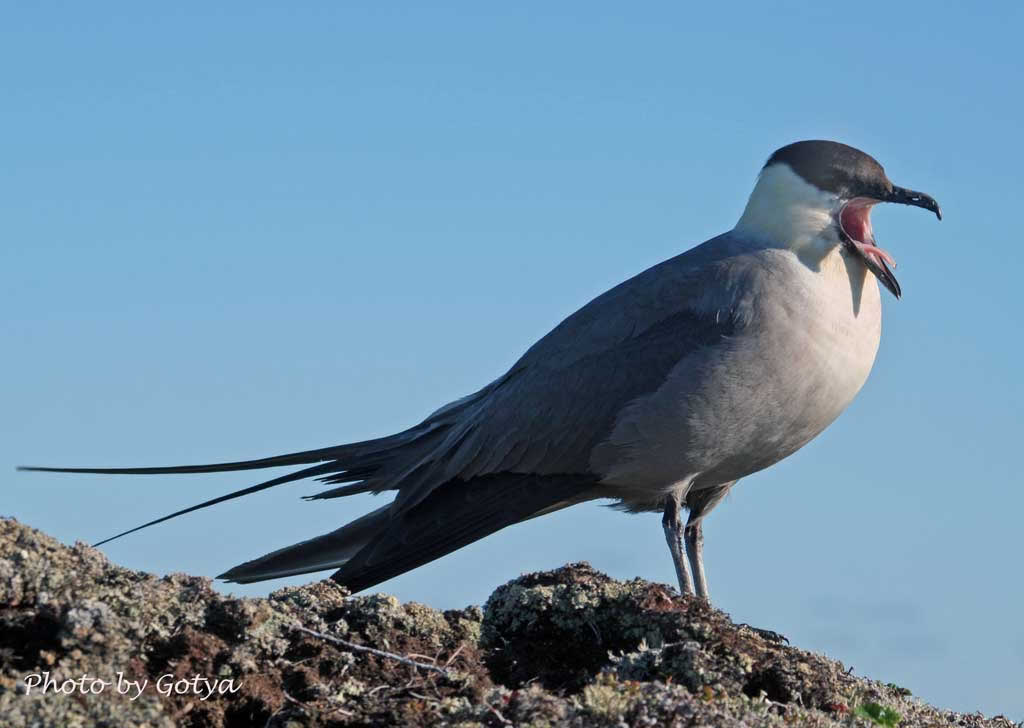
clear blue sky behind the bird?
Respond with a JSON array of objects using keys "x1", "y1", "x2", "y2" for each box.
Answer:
[{"x1": 0, "y1": 2, "x2": 1024, "y2": 720}]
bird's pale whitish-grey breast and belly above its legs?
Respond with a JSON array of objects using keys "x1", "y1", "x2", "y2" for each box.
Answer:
[{"x1": 592, "y1": 251, "x2": 882, "y2": 498}]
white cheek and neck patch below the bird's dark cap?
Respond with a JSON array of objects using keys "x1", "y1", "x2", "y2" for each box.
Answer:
[{"x1": 735, "y1": 164, "x2": 840, "y2": 257}]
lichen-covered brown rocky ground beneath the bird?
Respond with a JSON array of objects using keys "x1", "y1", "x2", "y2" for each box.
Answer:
[{"x1": 0, "y1": 519, "x2": 1024, "y2": 728}]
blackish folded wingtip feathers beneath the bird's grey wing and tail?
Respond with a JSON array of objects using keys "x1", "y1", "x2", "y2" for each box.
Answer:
[{"x1": 221, "y1": 473, "x2": 595, "y2": 593}]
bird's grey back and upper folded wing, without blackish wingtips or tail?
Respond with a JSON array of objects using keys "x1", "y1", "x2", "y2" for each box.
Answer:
[{"x1": 385, "y1": 233, "x2": 770, "y2": 512}]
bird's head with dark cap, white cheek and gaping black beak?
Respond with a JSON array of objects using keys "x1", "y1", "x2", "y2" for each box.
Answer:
[{"x1": 736, "y1": 140, "x2": 942, "y2": 298}]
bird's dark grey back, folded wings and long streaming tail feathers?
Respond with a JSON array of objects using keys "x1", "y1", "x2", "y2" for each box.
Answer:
[{"x1": 30, "y1": 233, "x2": 770, "y2": 589}]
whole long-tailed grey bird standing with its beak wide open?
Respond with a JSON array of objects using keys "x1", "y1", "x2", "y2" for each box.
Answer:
[{"x1": 20, "y1": 140, "x2": 942, "y2": 600}]
